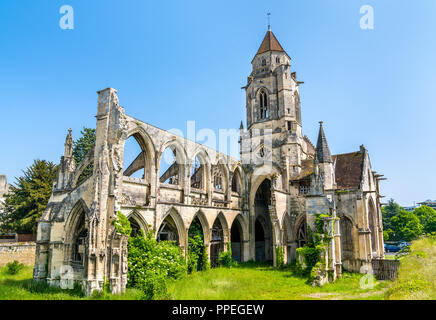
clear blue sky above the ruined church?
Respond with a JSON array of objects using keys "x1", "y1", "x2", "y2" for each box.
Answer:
[{"x1": 0, "y1": 0, "x2": 436, "y2": 205}]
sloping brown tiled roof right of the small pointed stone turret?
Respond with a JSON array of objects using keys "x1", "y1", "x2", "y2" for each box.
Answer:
[{"x1": 332, "y1": 151, "x2": 364, "y2": 190}]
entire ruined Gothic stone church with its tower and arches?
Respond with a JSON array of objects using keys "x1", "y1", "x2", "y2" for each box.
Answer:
[{"x1": 34, "y1": 29, "x2": 384, "y2": 294}]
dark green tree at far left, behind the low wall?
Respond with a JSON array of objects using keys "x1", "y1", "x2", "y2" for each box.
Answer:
[{"x1": 0, "y1": 160, "x2": 57, "y2": 233}]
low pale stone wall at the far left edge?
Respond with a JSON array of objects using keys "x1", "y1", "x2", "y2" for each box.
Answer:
[{"x1": 0, "y1": 242, "x2": 36, "y2": 267}]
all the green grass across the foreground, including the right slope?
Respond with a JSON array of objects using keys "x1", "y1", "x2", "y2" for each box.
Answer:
[{"x1": 0, "y1": 238, "x2": 436, "y2": 300}]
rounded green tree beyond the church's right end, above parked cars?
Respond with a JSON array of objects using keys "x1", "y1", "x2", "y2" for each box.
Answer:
[{"x1": 391, "y1": 210, "x2": 422, "y2": 241}]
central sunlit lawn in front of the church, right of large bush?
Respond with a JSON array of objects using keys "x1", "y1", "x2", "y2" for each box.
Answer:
[{"x1": 169, "y1": 263, "x2": 389, "y2": 300}]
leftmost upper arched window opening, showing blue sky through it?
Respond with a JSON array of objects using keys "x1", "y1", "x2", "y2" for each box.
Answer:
[{"x1": 123, "y1": 135, "x2": 146, "y2": 179}]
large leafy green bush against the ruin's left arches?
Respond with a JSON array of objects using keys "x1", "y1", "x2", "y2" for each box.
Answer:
[{"x1": 127, "y1": 231, "x2": 186, "y2": 299}]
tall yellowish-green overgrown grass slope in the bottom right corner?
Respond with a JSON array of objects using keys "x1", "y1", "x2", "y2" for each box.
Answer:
[{"x1": 386, "y1": 237, "x2": 436, "y2": 300}]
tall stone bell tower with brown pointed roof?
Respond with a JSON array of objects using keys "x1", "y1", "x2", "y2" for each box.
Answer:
[{"x1": 241, "y1": 27, "x2": 306, "y2": 181}]
